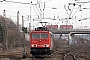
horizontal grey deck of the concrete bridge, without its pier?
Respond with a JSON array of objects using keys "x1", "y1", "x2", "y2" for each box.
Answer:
[{"x1": 50, "y1": 29, "x2": 90, "y2": 34}]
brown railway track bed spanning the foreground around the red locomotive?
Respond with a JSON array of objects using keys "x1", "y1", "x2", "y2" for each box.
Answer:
[{"x1": 0, "y1": 44, "x2": 90, "y2": 60}]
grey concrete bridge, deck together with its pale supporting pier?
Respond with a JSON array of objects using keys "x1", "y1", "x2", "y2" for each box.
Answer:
[{"x1": 50, "y1": 29, "x2": 90, "y2": 45}]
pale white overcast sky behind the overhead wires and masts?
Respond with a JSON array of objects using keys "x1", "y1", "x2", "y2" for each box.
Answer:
[{"x1": 0, "y1": 0, "x2": 90, "y2": 28}]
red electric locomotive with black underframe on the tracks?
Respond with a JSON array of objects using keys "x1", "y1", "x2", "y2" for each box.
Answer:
[{"x1": 30, "y1": 27, "x2": 53, "y2": 55}]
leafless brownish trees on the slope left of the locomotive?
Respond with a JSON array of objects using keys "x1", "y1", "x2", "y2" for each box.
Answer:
[{"x1": 0, "y1": 16, "x2": 24, "y2": 48}]
